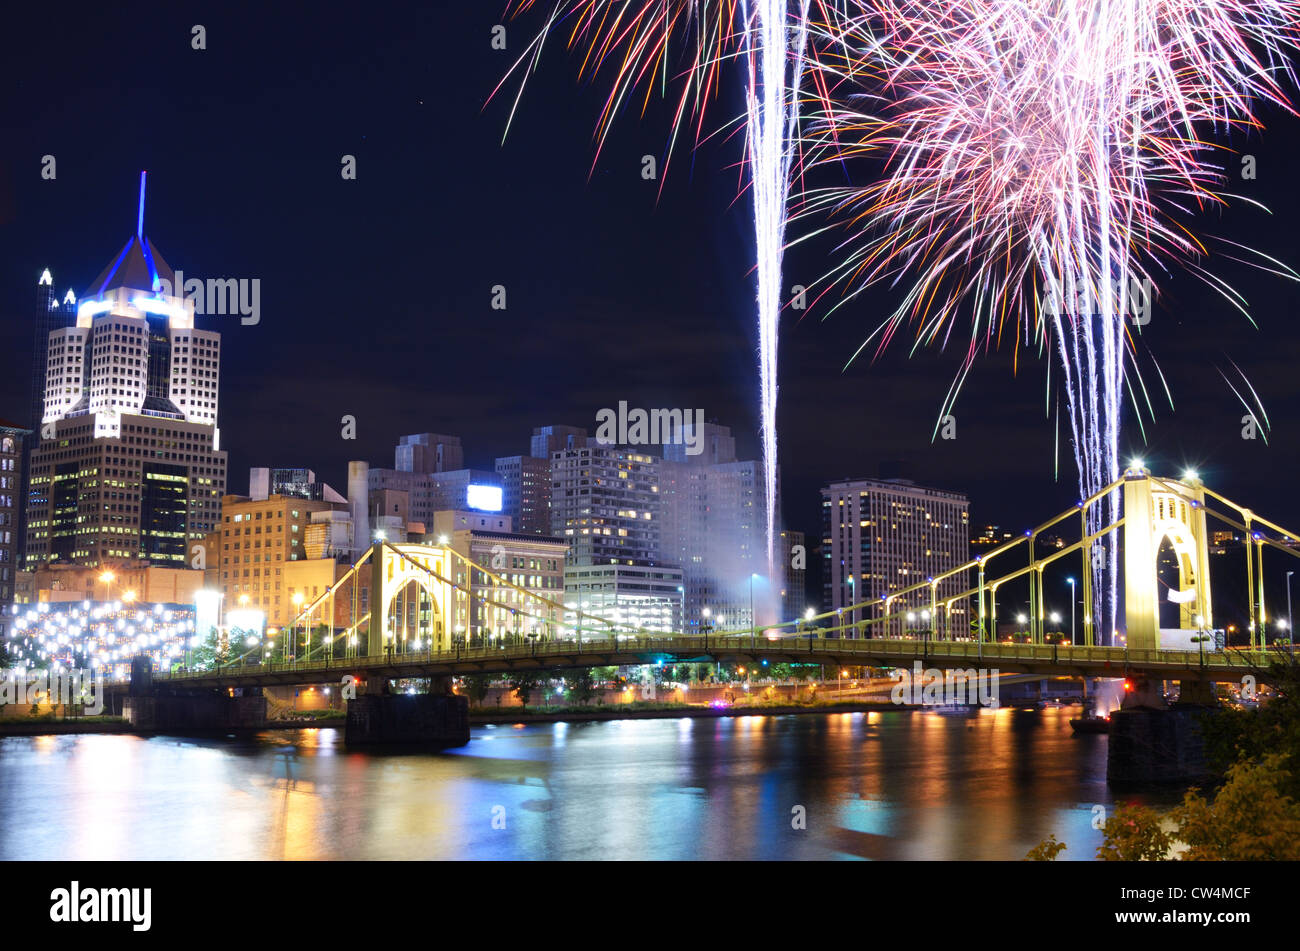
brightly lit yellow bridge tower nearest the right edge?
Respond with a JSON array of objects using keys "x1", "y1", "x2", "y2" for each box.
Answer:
[{"x1": 1122, "y1": 466, "x2": 1213, "y2": 650}]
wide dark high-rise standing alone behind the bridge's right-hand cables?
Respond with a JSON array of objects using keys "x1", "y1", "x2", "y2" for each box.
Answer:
[{"x1": 822, "y1": 479, "x2": 971, "y2": 637}]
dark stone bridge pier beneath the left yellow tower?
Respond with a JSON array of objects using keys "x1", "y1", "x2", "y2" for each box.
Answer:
[{"x1": 343, "y1": 677, "x2": 469, "y2": 750}]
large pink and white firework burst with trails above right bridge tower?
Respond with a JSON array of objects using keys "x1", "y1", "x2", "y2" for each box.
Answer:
[{"x1": 800, "y1": 0, "x2": 1300, "y2": 638}]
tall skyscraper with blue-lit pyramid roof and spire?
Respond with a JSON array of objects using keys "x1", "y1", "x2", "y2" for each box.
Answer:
[{"x1": 26, "y1": 174, "x2": 226, "y2": 569}]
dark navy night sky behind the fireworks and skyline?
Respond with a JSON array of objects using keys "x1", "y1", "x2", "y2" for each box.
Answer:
[{"x1": 0, "y1": 0, "x2": 1300, "y2": 615}]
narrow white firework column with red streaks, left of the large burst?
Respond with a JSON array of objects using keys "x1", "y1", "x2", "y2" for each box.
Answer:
[{"x1": 493, "y1": 0, "x2": 820, "y2": 587}]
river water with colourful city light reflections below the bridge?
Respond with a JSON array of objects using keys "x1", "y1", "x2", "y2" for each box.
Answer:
[{"x1": 0, "y1": 708, "x2": 1177, "y2": 860}]
